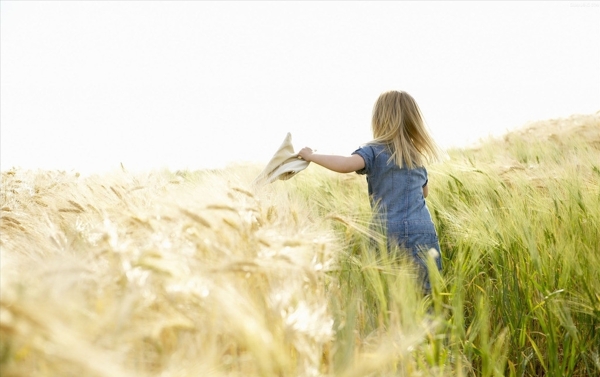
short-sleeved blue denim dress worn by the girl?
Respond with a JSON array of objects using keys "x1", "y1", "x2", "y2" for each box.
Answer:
[{"x1": 352, "y1": 144, "x2": 442, "y2": 293}]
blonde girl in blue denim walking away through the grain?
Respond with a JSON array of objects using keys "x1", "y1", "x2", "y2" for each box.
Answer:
[{"x1": 298, "y1": 91, "x2": 442, "y2": 293}]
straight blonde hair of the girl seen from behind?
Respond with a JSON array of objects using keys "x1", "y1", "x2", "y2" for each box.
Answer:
[{"x1": 371, "y1": 91, "x2": 441, "y2": 169}]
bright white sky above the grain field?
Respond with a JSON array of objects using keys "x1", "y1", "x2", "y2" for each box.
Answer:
[{"x1": 0, "y1": 1, "x2": 600, "y2": 172}]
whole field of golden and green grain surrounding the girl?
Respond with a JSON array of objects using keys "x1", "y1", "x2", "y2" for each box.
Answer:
[{"x1": 0, "y1": 112, "x2": 600, "y2": 377}]
